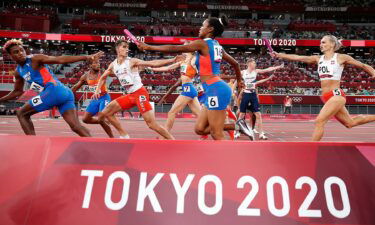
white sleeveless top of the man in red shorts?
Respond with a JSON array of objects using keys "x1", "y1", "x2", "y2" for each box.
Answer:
[{"x1": 113, "y1": 57, "x2": 143, "y2": 93}]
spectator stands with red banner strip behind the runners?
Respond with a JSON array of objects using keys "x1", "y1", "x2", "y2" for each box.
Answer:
[{"x1": 0, "y1": 0, "x2": 375, "y2": 113}]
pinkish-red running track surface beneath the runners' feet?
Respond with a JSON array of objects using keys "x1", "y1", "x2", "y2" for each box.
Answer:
[{"x1": 0, "y1": 116, "x2": 375, "y2": 142}]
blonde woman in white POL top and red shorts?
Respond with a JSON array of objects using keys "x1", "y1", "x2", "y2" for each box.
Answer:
[{"x1": 271, "y1": 35, "x2": 375, "y2": 141}]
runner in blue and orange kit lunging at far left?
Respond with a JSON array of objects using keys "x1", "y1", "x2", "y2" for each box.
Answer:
[{"x1": 0, "y1": 39, "x2": 103, "y2": 137}]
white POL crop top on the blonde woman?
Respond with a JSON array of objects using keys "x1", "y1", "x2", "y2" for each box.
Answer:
[{"x1": 318, "y1": 53, "x2": 344, "y2": 80}]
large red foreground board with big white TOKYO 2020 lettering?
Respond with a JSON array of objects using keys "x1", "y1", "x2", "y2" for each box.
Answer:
[{"x1": 0, "y1": 136, "x2": 375, "y2": 225}]
